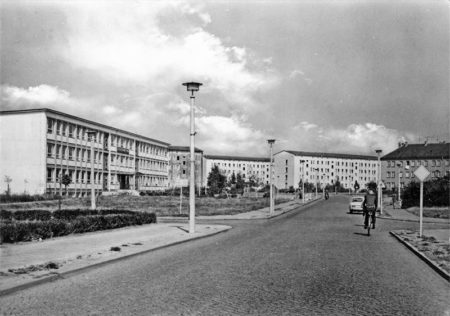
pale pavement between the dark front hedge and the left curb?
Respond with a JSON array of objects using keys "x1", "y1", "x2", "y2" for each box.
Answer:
[{"x1": 0, "y1": 223, "x2": 231, "y2": 295}]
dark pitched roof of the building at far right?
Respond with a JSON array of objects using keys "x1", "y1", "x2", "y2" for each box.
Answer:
[{"x1": 381, "y1": 143, "x2": 450, "y2": 160}]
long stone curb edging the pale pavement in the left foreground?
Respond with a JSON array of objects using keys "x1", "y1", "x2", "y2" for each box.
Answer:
[{"x1": 0, "y1": 227, "x2": 232, "y2": 297}]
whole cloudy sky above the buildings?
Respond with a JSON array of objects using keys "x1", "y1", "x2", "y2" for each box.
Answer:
[{"x1": 0, "y1": 0, "x2": 450, "y2": 156}]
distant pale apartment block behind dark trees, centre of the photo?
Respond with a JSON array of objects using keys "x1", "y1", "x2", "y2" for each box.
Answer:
[{"x1": 203, "y1": 155, "x2": 270, "y2": 186}]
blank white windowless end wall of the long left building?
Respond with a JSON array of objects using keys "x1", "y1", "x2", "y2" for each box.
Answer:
[{"x1": 0, "y1": 112, "x2": 47, "y2": 194}]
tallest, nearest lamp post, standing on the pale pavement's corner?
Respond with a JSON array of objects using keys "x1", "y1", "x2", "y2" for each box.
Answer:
[{"x1": 183, "y1": 82, "x2": 202, "y2": 234}]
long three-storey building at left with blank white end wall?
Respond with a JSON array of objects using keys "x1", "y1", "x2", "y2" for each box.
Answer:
[{"x1": 0, "y1": 109, "x2": 169, "y2": 196}]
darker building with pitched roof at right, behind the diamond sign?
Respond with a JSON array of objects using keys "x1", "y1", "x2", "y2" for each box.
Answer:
[{"x1": 381, "y1": 143, "x2": 450, "y2": 190}]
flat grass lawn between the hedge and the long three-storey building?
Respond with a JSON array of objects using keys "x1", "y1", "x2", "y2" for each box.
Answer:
[{"x1": 0, "y1": 195, "x2": 289, "y2": 216}]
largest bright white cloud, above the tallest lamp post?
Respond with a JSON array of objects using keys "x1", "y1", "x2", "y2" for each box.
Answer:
[{"x1": 59, "y1": 1, "x2": 278, "y2": 108}]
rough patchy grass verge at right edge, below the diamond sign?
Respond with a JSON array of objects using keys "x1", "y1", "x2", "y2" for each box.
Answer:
[{"x1": 395, "y1": 230, "x2": 450, "y2": 274}]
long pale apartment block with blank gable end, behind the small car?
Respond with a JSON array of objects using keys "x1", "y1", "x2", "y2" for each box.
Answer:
[{"x1": 274, "y1": 150, "x2": 378, "y2": 189}]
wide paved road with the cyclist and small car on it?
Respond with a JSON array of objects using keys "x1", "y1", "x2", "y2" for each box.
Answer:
[{"x1": 0, "y1": 197, "x2": 450, "y2": 315}]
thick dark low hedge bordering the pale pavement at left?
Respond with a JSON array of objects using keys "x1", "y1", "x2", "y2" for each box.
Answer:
[{"x1": 0, "y1": 212, "x2": 156, "y2": 243}]
